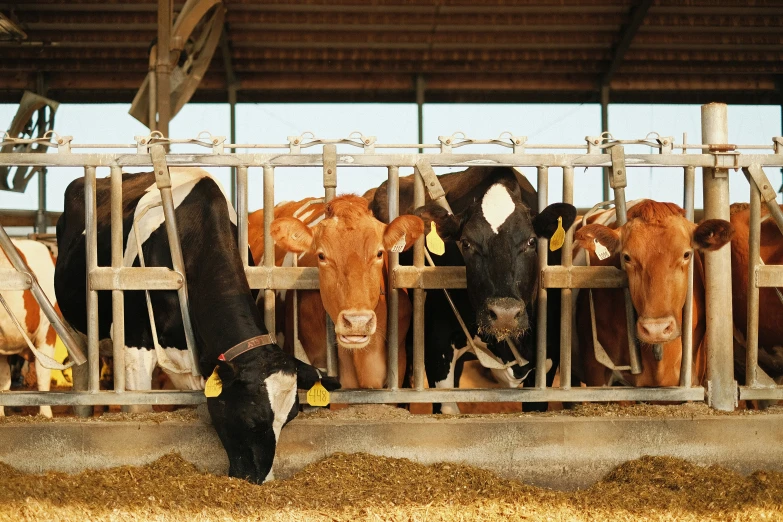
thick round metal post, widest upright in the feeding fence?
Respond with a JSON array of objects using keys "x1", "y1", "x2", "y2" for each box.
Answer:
[{"x1": 701, "y1": 103, "x2": 737, "y2": 411}]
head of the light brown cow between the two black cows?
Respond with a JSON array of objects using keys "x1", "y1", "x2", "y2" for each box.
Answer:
[{"x1": 272, "y1": 195, "x2": 424, "y2": 349}]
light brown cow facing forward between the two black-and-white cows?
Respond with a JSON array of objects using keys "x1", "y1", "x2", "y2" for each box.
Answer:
[{"x1": 249, "y1": 195, "x2": 424, "y2": 388}]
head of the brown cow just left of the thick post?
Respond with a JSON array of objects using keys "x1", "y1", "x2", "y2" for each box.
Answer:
[{"x1": 574, "y1": 200, "x2": 734, "y2": 344}]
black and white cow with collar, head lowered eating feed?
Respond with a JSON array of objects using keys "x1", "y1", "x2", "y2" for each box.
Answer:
[{"x1": 55, "y1": 168, "x2": 339, "y2": 483}]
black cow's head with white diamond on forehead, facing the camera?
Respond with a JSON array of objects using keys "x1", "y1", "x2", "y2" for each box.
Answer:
[{"x1": 415, "y1": 182, "x2": 576, "y2": 340}]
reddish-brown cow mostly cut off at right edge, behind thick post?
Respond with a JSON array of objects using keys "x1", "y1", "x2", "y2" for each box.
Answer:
[{"x1": 731, "y1": 203, "x2": 783, "y2": 383}]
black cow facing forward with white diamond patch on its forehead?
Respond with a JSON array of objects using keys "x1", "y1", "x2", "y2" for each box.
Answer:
[{"x1": 370, "y1": 167, "x2": 576, "y2": 413}]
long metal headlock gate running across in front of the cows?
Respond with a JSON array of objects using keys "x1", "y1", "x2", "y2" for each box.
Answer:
[{"x1": 0, "y1": 104, "x2": 783, "y2": 410}]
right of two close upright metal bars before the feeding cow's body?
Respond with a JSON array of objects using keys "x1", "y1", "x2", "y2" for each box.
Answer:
[{"x1": 110, "y1": 167, "x2": 125, "y2": 393}]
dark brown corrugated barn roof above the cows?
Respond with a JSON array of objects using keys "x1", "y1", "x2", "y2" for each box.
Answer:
[{"x1": 0, "y1": 0, "x2": 783, "y2": 104}]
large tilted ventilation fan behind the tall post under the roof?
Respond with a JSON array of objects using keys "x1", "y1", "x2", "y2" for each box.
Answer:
[{"x1": 128, "y1": 0, "x2": 226, "y2": 130}]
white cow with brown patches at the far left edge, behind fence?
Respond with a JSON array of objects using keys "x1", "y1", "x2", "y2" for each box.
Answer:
[{"x1": 0, "y1": 239, "x2": 57, "y2": 417}]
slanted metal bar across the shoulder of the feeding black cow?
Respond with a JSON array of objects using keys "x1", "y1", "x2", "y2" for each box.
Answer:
[{"x1": 150, "y1": 145, "x2": 201, "y2": 377}]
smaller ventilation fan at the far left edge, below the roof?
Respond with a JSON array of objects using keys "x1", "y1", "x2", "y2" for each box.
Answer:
[{"x1": 0, "y1": 91, "x2": 60, "y2": 192}]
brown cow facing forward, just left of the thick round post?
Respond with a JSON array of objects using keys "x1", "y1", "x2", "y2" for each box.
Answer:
[{"x1": 575, "y1": 200, "x2": 733, "y2": 386}]
